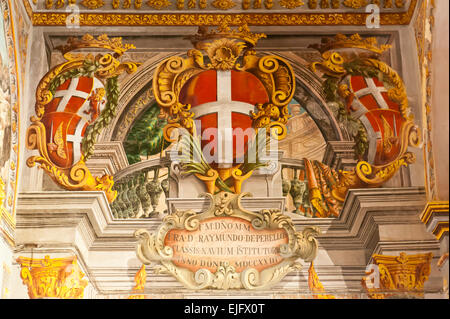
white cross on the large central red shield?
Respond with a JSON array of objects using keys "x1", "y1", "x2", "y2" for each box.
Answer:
[{"x1": 193, "y1": 70, "x2": 255, "y2": 168}]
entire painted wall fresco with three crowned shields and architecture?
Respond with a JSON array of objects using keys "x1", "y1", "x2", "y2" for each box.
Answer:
[{"x1": 0, "y1": 0, "x2": 448, "y2": 302}]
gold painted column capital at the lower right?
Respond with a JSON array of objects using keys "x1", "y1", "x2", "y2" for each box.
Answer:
[{"x1": 361, "y1": 253, "x2": 433, "y2": 299}]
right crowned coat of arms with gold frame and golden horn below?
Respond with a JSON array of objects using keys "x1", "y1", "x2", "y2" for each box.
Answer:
[{"x1": 285, "y1": 34, "x2": 421, "y2": 217}]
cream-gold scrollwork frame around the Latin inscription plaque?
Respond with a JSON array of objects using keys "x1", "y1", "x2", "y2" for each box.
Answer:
[{"x1": 135, "y1": 192, "x2": 320, "y2": 290}]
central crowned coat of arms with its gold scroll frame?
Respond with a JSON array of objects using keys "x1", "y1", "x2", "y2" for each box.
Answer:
[{"x1": 153, "y1": 24, "x2": 295, "y2": 194}]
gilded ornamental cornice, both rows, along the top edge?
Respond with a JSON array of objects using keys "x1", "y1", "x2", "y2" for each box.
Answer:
[{"x1": 24, "y1": 0, "x2": 418, "y2": 26}]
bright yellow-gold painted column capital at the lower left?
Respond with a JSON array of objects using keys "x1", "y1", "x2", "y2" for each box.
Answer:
[{"x1": 17, "y1": 256, "x2": 88, "y2": 299}]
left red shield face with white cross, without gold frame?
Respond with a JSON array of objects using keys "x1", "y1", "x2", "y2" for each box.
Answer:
[{"x1": 41, "y1": 77, "x2": 106, "y2": 168}]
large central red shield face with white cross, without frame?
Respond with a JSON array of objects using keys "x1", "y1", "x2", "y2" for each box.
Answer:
[{"x1": 180, "y1": 70, "x2": 269, "y2": 167}]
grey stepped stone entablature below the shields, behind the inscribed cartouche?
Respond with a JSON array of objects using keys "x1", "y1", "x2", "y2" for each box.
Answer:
[{"x1": 16, "y1": 187, "x2": 441, "y2": 298}]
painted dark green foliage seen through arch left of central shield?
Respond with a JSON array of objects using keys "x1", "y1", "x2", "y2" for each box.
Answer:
[{"x1": 124, "y1": 104, "x2": 169, "y2": 164}]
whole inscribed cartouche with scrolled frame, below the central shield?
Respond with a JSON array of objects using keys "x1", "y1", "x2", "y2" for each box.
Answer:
[{"x1": 135, "y1": 192, "x2": 319, "y2": 290}]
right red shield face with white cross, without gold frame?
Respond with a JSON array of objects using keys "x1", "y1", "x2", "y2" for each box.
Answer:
[{"x1": 346, "y1": 76, "x2": 405, "y2": 165}]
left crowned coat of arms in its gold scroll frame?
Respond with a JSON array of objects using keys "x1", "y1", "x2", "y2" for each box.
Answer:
[{"x1": 26, "y1": 34, "x2": 138, "y2": 202}]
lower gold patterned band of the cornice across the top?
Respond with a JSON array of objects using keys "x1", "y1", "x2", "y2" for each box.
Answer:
[{"x1": 29, "y1": 0, "x2": 417, "y2": 26}]
